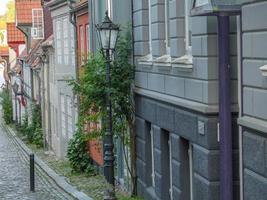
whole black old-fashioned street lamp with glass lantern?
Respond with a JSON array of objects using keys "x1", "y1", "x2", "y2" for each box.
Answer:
[{"x1": 96, "y1": 11, "x2": 119, "y2": 199}]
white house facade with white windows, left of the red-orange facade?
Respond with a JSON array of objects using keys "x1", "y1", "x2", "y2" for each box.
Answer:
[{"x1": 46, "y1": 0, "x2": 77, "y2": 158}]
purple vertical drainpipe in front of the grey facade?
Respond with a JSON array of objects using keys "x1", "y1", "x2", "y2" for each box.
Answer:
[{"x1": 218, "y1": 16, "x2": 233, "y2": 200}]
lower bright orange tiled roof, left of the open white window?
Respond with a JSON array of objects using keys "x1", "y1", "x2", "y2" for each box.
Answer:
[{"x1": 7, "y1": 22, "x2": 26, "y2": 43}]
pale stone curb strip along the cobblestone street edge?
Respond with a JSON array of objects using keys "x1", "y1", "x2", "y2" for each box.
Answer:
[{"x1": 2, "y1": 123, "x2": 93, "y2": 200}]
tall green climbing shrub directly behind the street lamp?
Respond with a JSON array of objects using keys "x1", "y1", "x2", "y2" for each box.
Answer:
[{"x1": 68, "y1": 28, "x2": 135, "y2": 194}]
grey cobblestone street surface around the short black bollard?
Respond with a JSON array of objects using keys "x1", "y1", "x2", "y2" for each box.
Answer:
[{"x1": 0, "y1": 126, "x2": 72, "y2": 200}]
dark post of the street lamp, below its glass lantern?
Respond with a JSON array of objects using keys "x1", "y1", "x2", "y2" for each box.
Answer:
[{"x1": 104, "y1": 50, "x2": 115, "y2": 200}]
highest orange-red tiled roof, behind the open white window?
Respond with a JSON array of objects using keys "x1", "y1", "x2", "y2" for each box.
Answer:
[{"x1": 15, "y1": 0, "x2": 42, "y2": 24}]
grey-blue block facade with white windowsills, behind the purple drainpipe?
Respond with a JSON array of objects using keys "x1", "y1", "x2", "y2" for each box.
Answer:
[{"x1": 133, "y1": 0, "x2": 239, "y2": 200}]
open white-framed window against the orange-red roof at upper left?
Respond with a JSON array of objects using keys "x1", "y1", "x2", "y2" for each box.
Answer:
[{"x1": 31, "y1": 9, "x2": 44, "y2": 39}]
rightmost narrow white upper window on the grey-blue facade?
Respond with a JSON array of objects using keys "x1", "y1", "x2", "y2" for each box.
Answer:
[{"x1": 185, "y1": 0, "x2": 192, "y2": 55}]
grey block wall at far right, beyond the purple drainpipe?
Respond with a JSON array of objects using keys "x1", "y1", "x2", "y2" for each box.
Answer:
[{"x1": 239, "y1": 1, "x2": 267, "y2": 200}]
